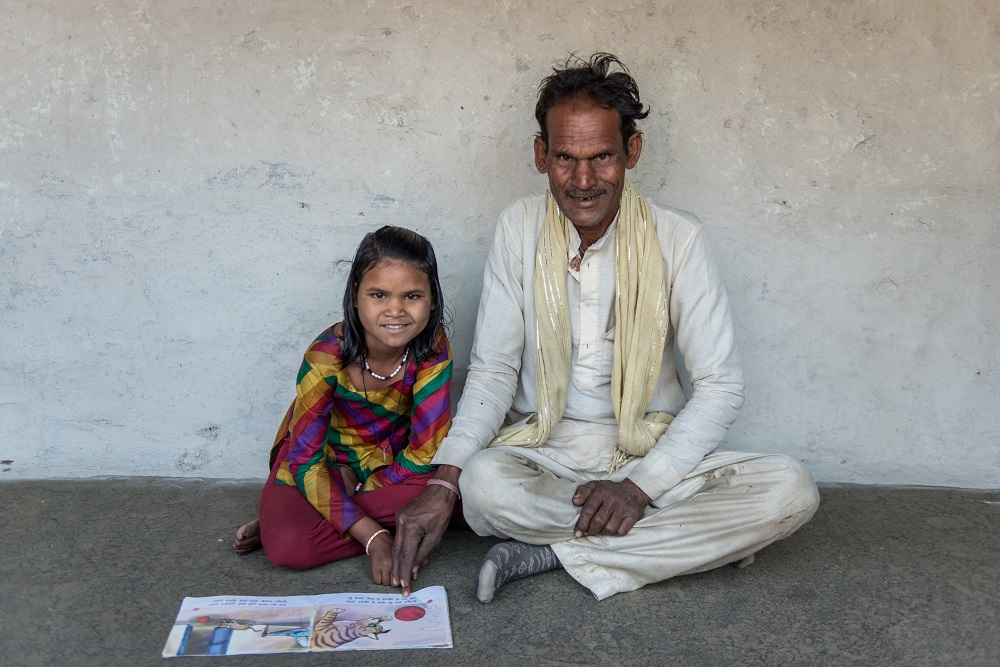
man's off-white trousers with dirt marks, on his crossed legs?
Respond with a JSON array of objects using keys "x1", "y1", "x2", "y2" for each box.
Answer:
[{"x1": 460, "y1": 447, "x2": 819, "y2": 600}]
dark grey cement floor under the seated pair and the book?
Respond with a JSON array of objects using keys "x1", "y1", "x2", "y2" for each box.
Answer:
[{"x1": 0, "y1": 479, "x2": 1000, "y2": 667}]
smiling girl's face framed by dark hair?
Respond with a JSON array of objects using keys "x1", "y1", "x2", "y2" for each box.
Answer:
[{"x1": 354, "y1": 259, "x2": 437, "y2": 358}]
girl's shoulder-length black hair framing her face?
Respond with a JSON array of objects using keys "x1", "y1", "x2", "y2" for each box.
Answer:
[{"x1": 343, "y1": 225, "x2": 444, "y2": 366}]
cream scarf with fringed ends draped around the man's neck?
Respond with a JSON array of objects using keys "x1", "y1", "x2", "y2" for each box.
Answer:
[{"x1": 489, "y1": 181, "x2": 672, "y2": 472}]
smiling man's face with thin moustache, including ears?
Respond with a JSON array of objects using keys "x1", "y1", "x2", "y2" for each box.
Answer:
[{"x1": 535, "y1": 98, "x2": 642, "y2": 243}]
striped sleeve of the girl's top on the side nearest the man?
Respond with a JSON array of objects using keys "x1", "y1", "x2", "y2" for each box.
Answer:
[{"x1": 365, "y1": 329, "x2": 452, "y2": 491}]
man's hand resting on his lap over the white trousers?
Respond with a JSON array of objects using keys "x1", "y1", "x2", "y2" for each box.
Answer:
[{"x1": 576, "y1": 479, "x2": 652, "y2": 539}]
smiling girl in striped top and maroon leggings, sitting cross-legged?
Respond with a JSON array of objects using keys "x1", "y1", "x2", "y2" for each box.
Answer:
[{"x1": 233, "y1": 226, "x2": 451, "y2": 585}]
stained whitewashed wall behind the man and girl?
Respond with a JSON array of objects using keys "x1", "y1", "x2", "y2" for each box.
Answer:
[{"x1": 0, "y1": 0, "x2": 1000, "y2": 488}]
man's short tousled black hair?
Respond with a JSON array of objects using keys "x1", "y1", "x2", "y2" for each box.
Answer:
[{"x1": 535, "y1": 53, "x2": 649, "y2": 154}]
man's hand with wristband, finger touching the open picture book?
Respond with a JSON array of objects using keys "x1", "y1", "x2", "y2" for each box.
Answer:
[{"x1": 392, "y1": 466, "x2": 462, "y2": 597}]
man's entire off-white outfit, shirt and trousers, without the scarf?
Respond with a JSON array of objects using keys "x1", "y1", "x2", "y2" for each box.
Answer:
[{"x1": 434, "y1": 195, "x2": 818, "y2": 599}]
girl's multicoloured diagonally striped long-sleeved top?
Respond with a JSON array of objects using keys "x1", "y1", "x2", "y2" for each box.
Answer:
[{"x1": 271, "y1": 325, "x2": 452, "y2": 535}]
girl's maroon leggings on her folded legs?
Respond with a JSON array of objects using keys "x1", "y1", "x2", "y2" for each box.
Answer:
[{"x1": 257, "y1": 464, "x2": 461, "y2": 570}]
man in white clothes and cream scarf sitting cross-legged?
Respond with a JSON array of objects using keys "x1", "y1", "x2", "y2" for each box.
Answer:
[{"x1": 393, "y1": 54, "x2": 819, "y2": 602}]
